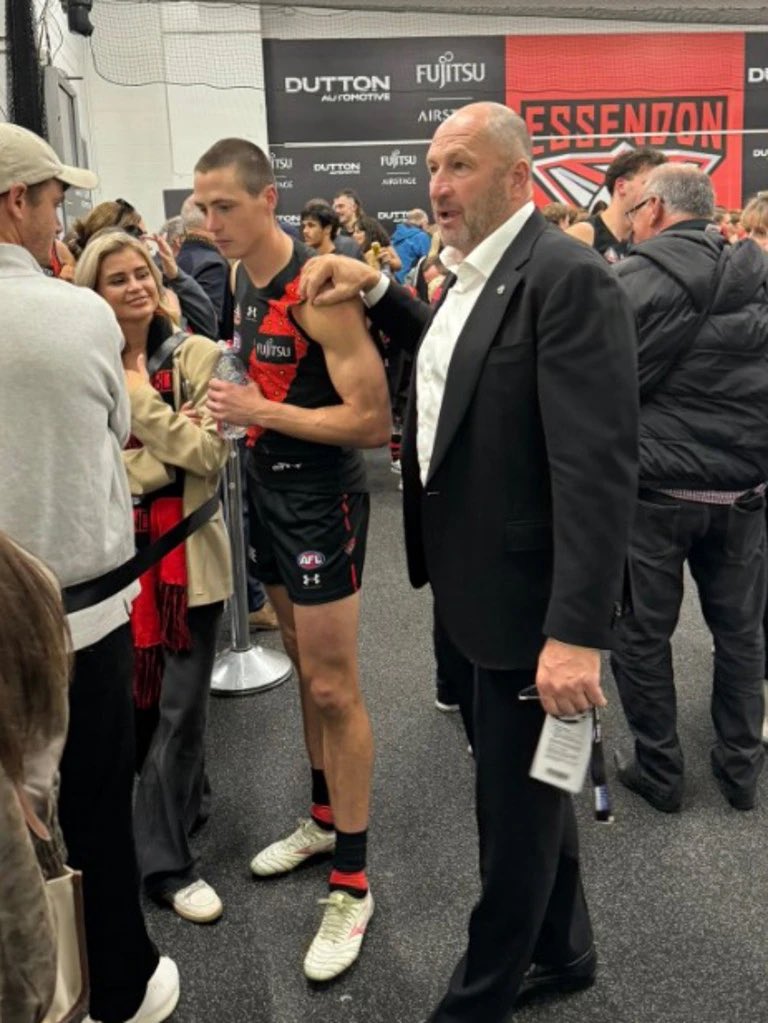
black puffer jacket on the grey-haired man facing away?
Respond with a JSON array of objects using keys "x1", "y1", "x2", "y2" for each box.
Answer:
[{"x1": 616, "y1": 228, "x2": 768, "y2": 490}]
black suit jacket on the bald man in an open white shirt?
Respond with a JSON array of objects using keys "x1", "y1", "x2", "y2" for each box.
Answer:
[{"x1": 370, "y1": 212, "x2": 638, "y2": 669}]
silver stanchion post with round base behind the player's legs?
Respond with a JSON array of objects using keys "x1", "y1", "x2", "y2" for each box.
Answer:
[{"x1": 211, "y1": 440, "x2": 292, "y2": 696}]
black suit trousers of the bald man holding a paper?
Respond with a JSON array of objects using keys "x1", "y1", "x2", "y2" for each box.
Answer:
[{"x1": 430, "y1": 668, "x2": 593, "y2": 1023}]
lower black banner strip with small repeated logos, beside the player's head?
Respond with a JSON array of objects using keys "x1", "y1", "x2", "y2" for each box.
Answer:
[{"x1": 270, "y1": 143, "x2": 430, "y2": 229}]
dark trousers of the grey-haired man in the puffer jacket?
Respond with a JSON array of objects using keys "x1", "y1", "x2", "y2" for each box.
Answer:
[{"x1": 612, "y1": 492, "x2": 766, "y2": 795}]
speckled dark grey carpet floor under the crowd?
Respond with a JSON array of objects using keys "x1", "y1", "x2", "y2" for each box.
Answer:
[{"x1": 140, "y1": 452, "x2": 768, "y2": 1023}]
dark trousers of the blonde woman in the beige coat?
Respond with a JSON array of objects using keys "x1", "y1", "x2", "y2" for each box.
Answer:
[{"x1": 135, "y1": 602, "x2": 224, "y2": 897}]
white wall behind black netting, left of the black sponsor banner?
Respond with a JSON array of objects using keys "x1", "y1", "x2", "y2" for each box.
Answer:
[{"x1": 81, "y1": 3, "x2": 267, "y2": 228}]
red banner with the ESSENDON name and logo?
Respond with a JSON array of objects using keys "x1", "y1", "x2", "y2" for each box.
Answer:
[{"x1": 506, "y1": 33, "x2": 744, "y2": 207}]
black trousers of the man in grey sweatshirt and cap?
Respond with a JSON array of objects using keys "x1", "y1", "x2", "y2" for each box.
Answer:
[{"x1": 58, "y1": 624, "x2": 159, "y2": 1023}]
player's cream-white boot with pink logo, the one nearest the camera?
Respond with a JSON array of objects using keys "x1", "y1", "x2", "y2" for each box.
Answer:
[{"x1": 304, "y1": 891, "x2": 373, "y2": 980}]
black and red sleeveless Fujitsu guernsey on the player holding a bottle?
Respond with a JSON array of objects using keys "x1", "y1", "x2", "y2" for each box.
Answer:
[{"x1": 233, "y1": 240, "x2": 367, "y2": 493}]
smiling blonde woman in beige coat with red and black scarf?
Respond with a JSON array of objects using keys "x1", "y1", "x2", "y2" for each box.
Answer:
[{"x1": 75, "y1": 231, "x2": 232, "y2": 923}]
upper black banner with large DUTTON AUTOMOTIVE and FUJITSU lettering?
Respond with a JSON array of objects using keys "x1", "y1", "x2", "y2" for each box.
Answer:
[{"x1": 264, "y1": 36, "x2": 504, "y2": 143}]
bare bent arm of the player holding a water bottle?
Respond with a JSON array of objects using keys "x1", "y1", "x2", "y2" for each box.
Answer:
[{"x1": 208, "y1": 300, "x2": 392, "y2": 448}]
